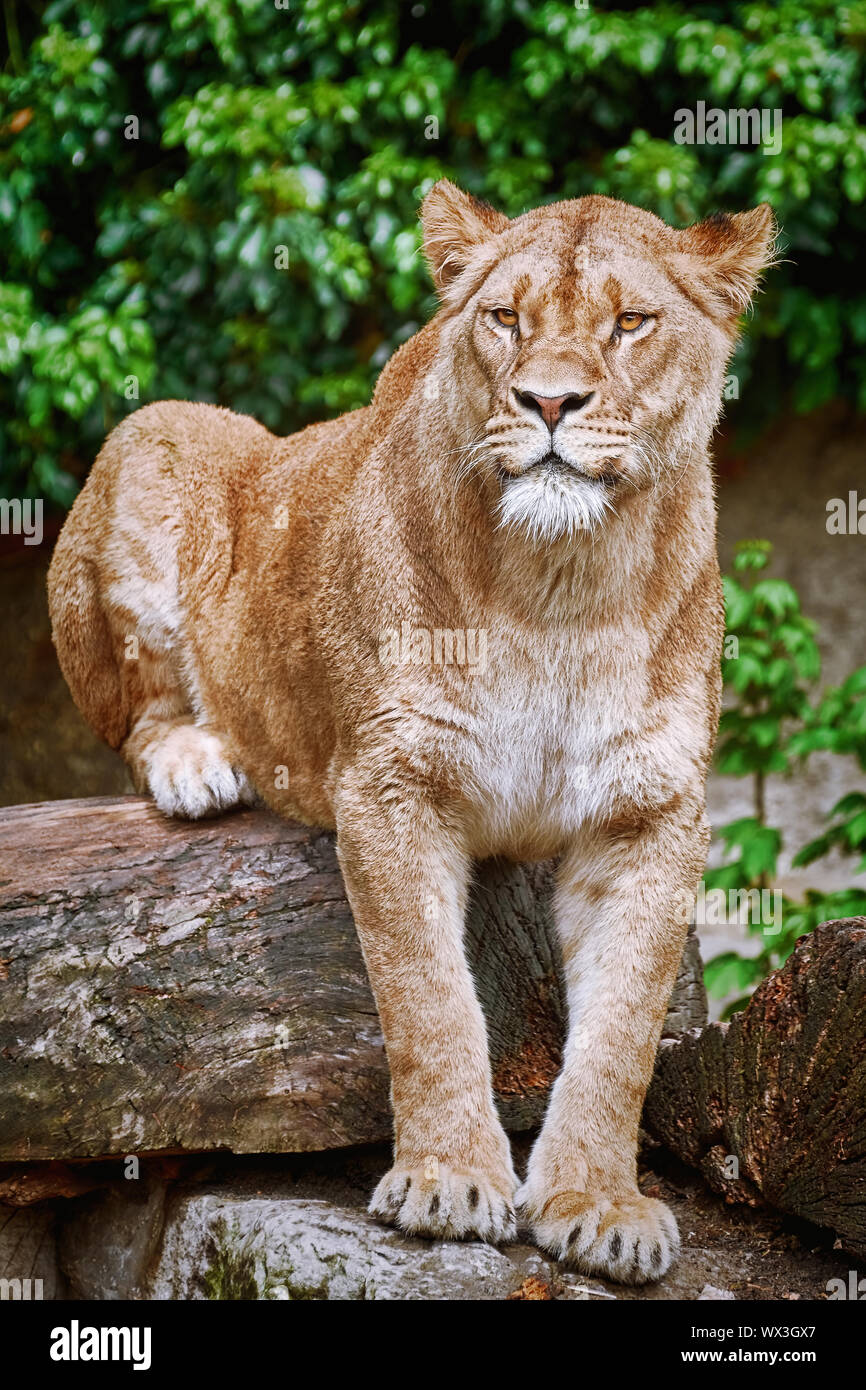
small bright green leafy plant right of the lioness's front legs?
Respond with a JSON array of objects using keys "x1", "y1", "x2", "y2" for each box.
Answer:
[{"x1": 705, "y1": 541, "x2": 866, "y2": 1016}]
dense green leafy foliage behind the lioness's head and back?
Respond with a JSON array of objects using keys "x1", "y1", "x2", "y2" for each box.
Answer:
[{"x1": 0, "y1": 0, "x2": 866, "y2": 505}]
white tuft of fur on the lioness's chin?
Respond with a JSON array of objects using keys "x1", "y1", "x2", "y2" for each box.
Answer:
[{"x1": 498, "y1": 468, "x2": 613, "y2": 543}]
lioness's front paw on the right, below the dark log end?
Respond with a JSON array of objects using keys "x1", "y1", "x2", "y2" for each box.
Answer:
[{"x1": 517, "y1": 1191, "x2": 680, "y2": 1284}]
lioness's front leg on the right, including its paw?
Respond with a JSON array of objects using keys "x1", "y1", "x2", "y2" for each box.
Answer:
[{"x1": 517, "y1": 796, "x2": 708, "y2": 1283}]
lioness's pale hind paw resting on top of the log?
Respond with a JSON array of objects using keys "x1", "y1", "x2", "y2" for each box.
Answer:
[{"x1": 146, "y1": 724, "x2": 256, "y2": 820}]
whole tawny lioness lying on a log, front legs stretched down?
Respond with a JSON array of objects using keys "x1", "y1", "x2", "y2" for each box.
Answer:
[{"x1": 49, "y1": 179, "x2": 773, "y2": 1283}]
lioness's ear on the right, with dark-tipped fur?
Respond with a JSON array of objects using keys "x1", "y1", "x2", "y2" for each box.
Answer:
[{"x1": 674, "y1": 203, "x2": 776, "y2": 318}]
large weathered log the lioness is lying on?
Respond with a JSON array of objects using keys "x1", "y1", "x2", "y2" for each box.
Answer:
[{"x1": 0, "y1": 796, "x2": 706, "y2": 1162}]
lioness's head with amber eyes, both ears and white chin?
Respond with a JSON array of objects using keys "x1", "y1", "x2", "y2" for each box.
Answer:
[{"x1": 423, "y1": 183, "x2": 773, "y2": 539}]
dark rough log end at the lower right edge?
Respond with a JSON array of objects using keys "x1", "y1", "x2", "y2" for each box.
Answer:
[{"x1": 644, "y1": 917, "x2": 866, "y2": 1255}]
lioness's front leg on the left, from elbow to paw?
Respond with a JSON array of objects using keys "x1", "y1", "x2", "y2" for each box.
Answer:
[{"x1": 336, "y1": 769, "x2": 517, "y2": 1241}]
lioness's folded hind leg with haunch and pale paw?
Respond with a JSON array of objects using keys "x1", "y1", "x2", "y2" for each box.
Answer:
[{"x1": 49, "y1": 400, "x2": 261, "y2": 820}]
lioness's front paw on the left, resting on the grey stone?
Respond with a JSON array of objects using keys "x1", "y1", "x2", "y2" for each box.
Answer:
[{"x1": 368, "y1": 1158, "x2": 517, "y2": 1245}]
